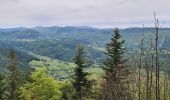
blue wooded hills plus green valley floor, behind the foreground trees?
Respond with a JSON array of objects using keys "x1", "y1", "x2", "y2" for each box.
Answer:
[{"x1": 0, "y1": 26, "x2": 170, "y2": 76}]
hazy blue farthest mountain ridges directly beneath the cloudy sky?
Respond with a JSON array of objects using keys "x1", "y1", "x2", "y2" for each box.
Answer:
[{"x1": 0, "y1": 26, "x2": 170, "y2": 47}]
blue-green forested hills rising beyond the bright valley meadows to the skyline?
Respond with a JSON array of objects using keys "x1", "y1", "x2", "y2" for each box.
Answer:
[{"x1": 0, "y1": 26, "x2": 170, "y2": 66}]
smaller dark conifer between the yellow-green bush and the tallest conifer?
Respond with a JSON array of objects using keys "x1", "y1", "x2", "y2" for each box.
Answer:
[{"x1": 73, "y1": 46, "x2": 92, "y2": 100}]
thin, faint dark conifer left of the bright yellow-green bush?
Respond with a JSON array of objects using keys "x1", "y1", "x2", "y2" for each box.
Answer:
[{"x1": 9, "y1": 50, "x2": 18, "y2": 100}]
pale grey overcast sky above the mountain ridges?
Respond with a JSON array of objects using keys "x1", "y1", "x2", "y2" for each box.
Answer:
[{"x1": 0, "y1": 0, "x2": 170, "y2": 28}]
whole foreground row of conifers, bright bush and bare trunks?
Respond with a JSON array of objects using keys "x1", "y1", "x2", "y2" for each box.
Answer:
[{"x1": 0, "y1": 15, "x2": 170, "y2": 100}]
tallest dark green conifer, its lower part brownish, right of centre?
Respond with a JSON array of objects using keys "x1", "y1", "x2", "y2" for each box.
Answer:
[{"x1": 102, "y1": 28, "x2": 131, "y2": 100}]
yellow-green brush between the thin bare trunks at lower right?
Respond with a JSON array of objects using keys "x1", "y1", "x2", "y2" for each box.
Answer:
[{"x1": 129, "y1": 69, "x2": 170, "y2": 100}]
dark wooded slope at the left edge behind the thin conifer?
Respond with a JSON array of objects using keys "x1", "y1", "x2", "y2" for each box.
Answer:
[{"x1": 0, "y1": 41, "x2": 36, "y2": 74}]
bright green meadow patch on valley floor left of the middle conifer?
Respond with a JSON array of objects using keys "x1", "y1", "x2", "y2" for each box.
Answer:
[{"x1": 29, "y1": 55, "x2": 75, "y2": 80}]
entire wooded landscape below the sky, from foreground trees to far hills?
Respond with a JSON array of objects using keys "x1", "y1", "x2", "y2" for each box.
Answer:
[{"x1": 0, "y1": 16, "x2": 170, "y2": 100}]
